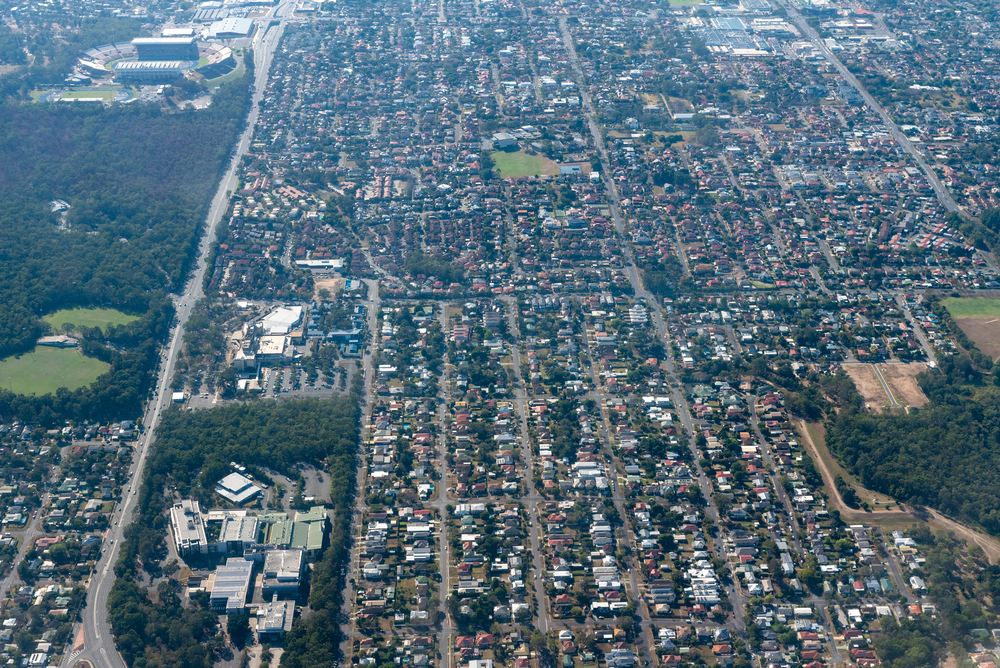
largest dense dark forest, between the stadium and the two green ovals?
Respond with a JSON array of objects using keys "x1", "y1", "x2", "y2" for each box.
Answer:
[{"x1": 0, "y1": 59, "x2": 252, "y2": 417}]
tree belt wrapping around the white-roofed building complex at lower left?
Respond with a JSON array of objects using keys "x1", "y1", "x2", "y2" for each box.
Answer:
[{"x1": 108, "y1": 392, "x2": 360, "y2": 668}]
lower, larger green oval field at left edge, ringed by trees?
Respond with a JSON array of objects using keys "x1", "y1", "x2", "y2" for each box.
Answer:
[{"x1": 0, "y1": 346, "x2": 111, "y2": 396}]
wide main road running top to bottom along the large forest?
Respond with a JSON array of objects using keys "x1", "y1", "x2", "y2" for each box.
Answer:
[{"x1": 62, "y1": 0, "x2": 294, "y2": 668}]
